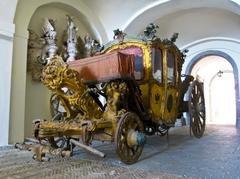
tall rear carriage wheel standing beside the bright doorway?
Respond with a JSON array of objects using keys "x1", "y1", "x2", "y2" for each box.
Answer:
[{"x1": 188, "y1": 80, "x2": 206, "y2": 138}]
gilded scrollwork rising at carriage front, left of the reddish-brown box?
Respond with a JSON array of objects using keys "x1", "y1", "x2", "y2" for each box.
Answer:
[{"x1": 42, "y1": 56, "x2": 102, "y2": 119}]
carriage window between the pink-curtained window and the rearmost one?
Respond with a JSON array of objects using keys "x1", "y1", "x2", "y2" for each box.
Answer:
[{"x1": 152, "y1": 49, "x2": 163, "y2": 83}]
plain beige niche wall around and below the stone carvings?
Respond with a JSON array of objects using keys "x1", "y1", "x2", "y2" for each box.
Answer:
[{"x1": 24, "y1": 3, "x2": 106, "y2": 137}]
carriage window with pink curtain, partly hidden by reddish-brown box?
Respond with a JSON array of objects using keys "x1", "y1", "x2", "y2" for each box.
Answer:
[{"x1": 120, "y1": 46, "x2": 144, "y2": 80}]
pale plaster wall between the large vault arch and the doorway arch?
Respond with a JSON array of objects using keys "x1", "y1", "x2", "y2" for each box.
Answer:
[{"x1": 152, "y1": 8, "x2": 240, "y2": 46}]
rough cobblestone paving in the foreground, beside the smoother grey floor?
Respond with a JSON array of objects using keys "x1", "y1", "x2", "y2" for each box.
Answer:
[{"x1": 0, "y1": 147, "x2": 188, "y2": 179}]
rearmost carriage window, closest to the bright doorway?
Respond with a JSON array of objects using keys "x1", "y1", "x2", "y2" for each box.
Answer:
[{"x1": 167, "y1": 51, "x2": 175, "y2": 85}]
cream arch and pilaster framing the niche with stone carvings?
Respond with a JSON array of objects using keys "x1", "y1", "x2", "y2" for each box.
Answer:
[{"x1": 9, "y1": 0, "x2": 107, "y2": 143}]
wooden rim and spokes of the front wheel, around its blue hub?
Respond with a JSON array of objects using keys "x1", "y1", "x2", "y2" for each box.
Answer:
[{"x1": 115, "y1": 113, "x2": 144, "y2": 164}]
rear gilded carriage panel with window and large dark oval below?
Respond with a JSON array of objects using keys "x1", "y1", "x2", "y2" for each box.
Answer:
[{"x1": 163, "y1": 49, "x2": 177, "y2": 124}]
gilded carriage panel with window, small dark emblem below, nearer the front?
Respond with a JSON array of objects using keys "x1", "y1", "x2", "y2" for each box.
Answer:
[{"x1": 149, "y1": 48, "x2": 164, "y2": 122}]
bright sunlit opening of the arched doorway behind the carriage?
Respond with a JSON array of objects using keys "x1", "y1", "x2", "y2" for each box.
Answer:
[{"x1": 191, "y1": 56, "x2": 236, "y2": 125}]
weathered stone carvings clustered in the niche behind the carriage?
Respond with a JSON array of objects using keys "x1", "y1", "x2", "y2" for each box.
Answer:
[{"x1": 27, "y1": 15, "x2": 102, "y2": 81}]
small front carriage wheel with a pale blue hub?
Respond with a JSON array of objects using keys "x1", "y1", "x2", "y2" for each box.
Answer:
[{"x1": 115, "y1": 112, "x2": 145, "y2": 164}]
